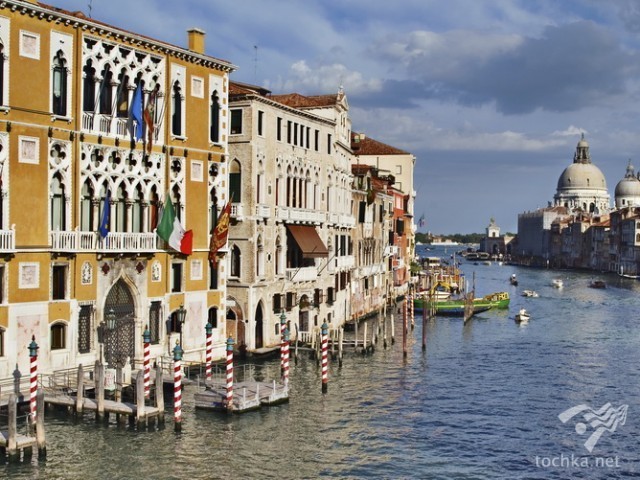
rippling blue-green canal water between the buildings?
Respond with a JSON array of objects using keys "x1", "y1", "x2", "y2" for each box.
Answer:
[{"x1": 0, "y1": 248, "x2": 640, "y2": 480}]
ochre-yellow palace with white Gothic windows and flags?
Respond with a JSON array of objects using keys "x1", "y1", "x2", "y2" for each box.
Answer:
[{"x1": 0, "y1": 1, "x2": 235, "y2": 379}]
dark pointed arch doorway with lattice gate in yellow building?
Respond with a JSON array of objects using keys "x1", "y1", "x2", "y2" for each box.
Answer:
[{"x1": 104, "y1": 279, "x2": 136, "y2": 368}]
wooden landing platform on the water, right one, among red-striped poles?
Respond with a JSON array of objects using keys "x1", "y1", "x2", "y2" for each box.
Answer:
[{"x1": 193, "y1": 380, "x2": 289, "y2": 413}]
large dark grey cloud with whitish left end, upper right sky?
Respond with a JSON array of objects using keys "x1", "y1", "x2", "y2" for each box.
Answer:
[{"x1": 367, "y1": 21, "x2": 639, "y2": 115}]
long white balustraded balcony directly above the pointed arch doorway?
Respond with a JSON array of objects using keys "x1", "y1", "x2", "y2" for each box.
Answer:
[{"x1": 49, "y1": 231, "x2": 158, "y2": 253}]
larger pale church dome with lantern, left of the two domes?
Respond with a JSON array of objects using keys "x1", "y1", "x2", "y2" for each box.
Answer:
[{"x1": 553, "y1": 133, "x2": 611, "y2": 213}]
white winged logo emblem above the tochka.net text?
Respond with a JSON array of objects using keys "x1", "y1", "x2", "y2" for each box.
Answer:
[{"x1": 558, "y1": 403, "x2": 629, "y2": 453}]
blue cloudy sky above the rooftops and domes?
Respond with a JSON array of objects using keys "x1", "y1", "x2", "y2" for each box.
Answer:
[{"x1": 46, "y1": 0, "x2": 640, "y2": 234}]
